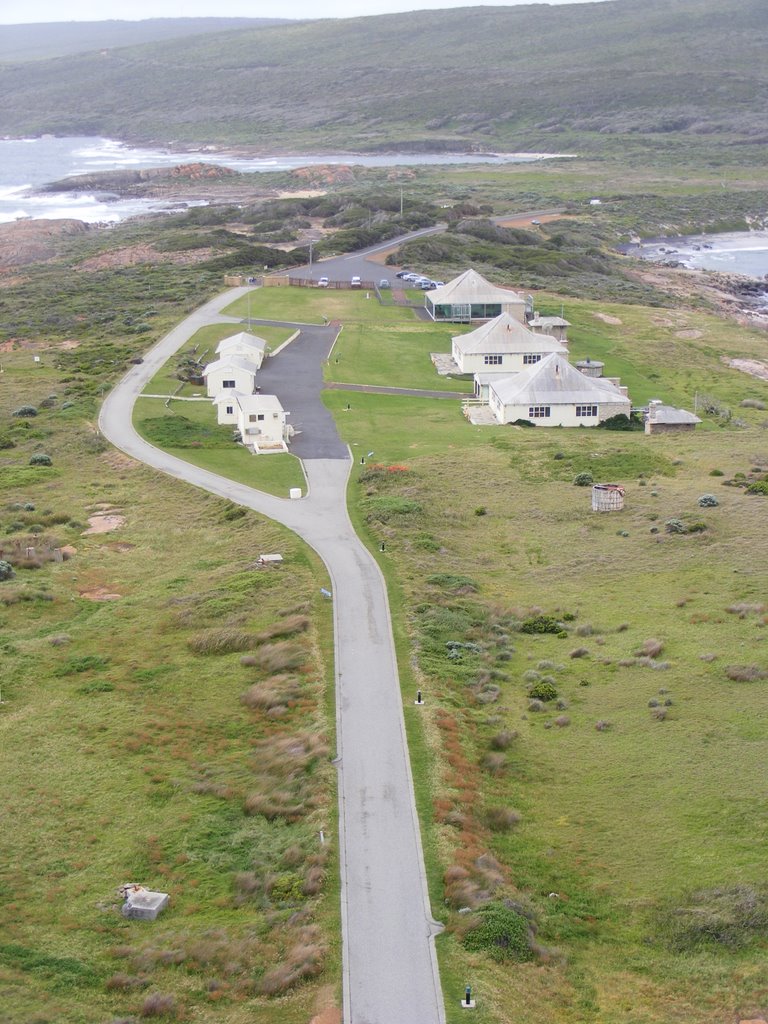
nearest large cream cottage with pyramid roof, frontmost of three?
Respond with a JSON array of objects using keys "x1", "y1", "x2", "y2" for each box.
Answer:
[{"x1": 488, "y1": 352, "x2": 632, "y2": 427}]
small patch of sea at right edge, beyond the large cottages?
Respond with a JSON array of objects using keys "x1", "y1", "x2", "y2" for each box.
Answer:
[{"x1": 629, "y1": 230, "x2": 768, "y2": 282}]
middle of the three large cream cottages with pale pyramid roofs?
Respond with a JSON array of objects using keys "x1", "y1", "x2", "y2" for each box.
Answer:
[{"x1": 451, "y1": 312, "x2": 568, "y2": 376}]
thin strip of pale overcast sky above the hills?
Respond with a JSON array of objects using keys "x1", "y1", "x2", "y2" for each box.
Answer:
[{"x1": 0, "y1": 0, "x2": 610, "y2": 25}]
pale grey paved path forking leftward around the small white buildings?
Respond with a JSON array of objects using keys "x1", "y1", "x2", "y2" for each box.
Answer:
[{"x1": 99, "y1": 289, "x2": 444, "y2": 1024}]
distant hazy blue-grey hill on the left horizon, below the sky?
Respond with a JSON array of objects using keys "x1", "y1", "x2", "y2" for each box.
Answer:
[{"x1": 0, "y1": 17, "x2": 294, "y2": 63}]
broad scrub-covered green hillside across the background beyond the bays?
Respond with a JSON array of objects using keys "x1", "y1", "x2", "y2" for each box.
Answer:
[{"x1": 0, "y1": 0, "x2": 768, "y2": 152}]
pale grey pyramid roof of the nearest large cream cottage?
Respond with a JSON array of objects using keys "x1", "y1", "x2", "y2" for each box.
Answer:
[{"x1": 490, "y1": 352, "x2": 631, "y2": 407}]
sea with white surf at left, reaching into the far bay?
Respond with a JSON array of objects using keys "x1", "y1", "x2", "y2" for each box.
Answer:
[{"x1": 0, "y1": 136, "x2": 566, "y2": 223}]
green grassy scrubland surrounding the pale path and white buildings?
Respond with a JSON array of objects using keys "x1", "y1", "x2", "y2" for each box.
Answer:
[{"x1": 0, "y1": 153, "x2": 768, "y2": 1024}]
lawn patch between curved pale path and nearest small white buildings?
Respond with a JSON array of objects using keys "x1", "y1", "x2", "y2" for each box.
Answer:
[{"x1": 133, "y1": 398, "x2": 306, "y2": 498}]
